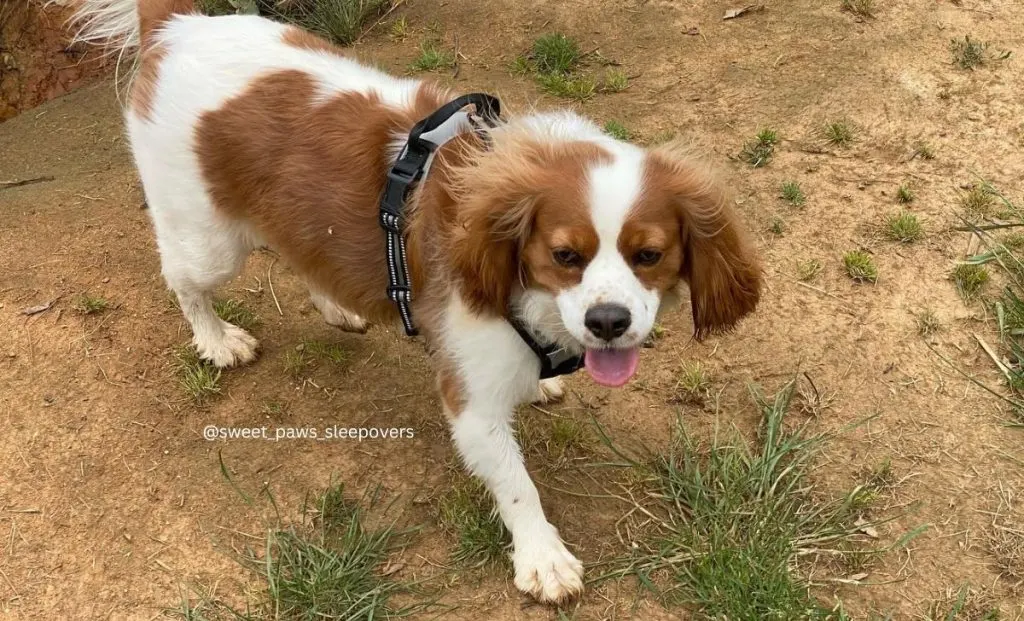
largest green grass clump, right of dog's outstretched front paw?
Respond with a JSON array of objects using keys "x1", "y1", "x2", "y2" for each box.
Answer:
[{"x1": 597, "y1": 381, "x2": 908, "y2": 620}]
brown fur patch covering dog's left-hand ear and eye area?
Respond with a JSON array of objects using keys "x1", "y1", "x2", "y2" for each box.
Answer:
[{"x1": 452, "y1": 141, "x2": 610, "y2": 316}]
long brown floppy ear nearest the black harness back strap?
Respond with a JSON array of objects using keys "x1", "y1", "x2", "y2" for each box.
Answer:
[{"x1": 450, "y1": 144, "x2": 539, "y2": 316}]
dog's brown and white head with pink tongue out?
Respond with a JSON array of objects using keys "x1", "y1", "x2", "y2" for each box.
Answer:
[{"x1": 452, "y1": 115, "x2": 762, "y2": 385}]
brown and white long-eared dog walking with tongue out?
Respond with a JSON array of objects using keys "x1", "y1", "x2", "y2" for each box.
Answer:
[{"x1": 72, "y1": 0, "x2": 762, "y2": 602}]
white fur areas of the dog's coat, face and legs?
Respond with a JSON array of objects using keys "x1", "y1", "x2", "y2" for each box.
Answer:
[{"x1": 72, "y1": 0, "x2": 658, "y2": 602}]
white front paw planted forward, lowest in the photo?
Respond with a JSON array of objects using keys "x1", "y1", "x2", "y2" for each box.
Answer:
[{"x1": 512, "y1": 524, "x2": 583, "y2": 604}]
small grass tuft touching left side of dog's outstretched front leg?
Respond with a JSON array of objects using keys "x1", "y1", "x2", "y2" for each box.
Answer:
[{"x1": 437, "y1": 474, "x2": 511, "y2": 567}]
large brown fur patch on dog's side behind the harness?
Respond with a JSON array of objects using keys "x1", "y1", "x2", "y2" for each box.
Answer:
[{"x1": 196, "y1": 71, "x2": 443, "y2": 332}]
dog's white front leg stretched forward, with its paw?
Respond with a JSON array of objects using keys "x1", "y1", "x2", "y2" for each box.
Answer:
[{"x1": 451, "y1": 396, "x2": 583, "y2": 603}]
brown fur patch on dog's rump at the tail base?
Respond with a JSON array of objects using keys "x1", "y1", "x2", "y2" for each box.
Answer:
[{"x1": 128, "y1": 0, "x2": 196, "y2": 119}]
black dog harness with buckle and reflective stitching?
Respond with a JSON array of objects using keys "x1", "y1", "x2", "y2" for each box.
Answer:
[{"x1": 380, "y1": 93, "x2": 584, "y2": 379}]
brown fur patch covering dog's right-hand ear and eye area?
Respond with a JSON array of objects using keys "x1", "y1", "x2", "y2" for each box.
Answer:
[{"x1": 638, "y1": 148, "x2": 762, "y2": 339}]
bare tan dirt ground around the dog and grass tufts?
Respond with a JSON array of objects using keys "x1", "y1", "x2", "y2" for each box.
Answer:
[{"x1": 0, "y1": 0, "x2": 1024, "y2": 620}]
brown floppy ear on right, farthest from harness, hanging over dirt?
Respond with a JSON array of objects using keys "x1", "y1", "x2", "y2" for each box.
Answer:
[{"x1": 651, "y1": 148, "x2": 763, "y2": 340}]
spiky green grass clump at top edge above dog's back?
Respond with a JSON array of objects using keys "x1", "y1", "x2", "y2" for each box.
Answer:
[{"x1": 290, "y1": 0, "x2": 391, "y2": 45}]
